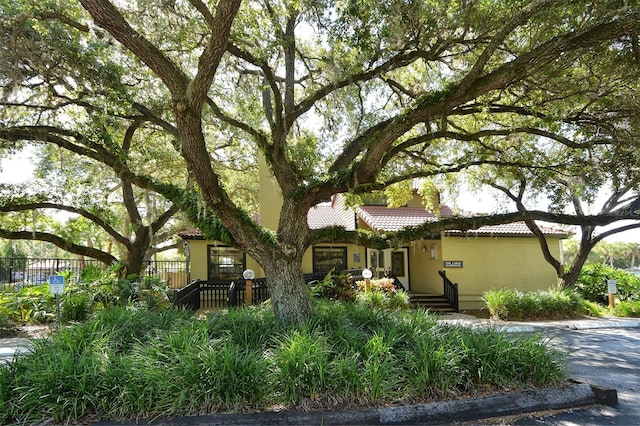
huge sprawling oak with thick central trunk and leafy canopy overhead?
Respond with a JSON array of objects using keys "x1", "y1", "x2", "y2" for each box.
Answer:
[{"x1": 0, "y1": 0, "x2": 640, "y2": 321}]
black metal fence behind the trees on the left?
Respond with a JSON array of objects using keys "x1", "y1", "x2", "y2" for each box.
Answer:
[{"x1": 0, "y1": 257, "x2": 189, "y2": 290}]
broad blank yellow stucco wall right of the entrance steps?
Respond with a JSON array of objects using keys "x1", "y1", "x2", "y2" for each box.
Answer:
[{"x1": 440, "y1": 236, "x2": 560, "y2": 309}]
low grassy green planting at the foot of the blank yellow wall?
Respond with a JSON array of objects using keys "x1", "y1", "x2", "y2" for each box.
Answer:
[{"x1": 483, "y1": 289, "x2": 589, "y2": 321}]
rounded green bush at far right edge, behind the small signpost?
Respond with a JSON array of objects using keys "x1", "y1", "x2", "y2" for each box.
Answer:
[{"x1": 575, "y1": 263, "x2": 640, "y2": 305}]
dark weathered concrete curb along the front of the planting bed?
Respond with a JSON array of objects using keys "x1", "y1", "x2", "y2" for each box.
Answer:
[{"x1": 102, "y1": 380, "x2": 618, "y2": 426}]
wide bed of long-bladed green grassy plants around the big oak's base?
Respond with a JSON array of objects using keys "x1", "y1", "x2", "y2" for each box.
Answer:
[{"x1": 0, "y1": 301, "x2": 565, "y2": 424}]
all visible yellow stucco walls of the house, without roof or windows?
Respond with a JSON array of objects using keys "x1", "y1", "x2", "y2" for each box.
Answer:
[{"x1": 189, "y1": 236, "x2": 561, "y2": 309}]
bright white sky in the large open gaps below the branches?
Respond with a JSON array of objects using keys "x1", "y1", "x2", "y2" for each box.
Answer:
[{"x1": 0, "y1": 151, "x2": 640, "y2": 243}]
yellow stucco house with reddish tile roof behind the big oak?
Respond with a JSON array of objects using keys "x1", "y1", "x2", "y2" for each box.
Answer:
[{"x1": 180, "y1": 184, "x2": 569, "y2": 309}]
